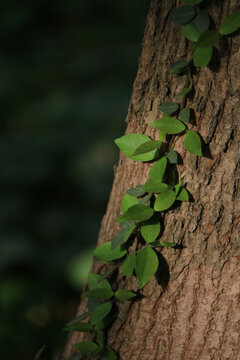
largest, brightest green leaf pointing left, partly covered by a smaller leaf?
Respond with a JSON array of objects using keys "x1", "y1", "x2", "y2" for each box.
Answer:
[{"x1": 114, "y1": 134, "x2": 158, "y2": 161}]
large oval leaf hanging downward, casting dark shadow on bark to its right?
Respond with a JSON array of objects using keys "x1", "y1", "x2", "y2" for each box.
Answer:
[{"x1": 136, "y1": 247, "x2": 158, "y2": 289}]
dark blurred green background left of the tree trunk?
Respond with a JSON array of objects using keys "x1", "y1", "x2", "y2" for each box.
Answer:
[{"x1": 0, "y1": 0, "x2": 148, "y2": 360}]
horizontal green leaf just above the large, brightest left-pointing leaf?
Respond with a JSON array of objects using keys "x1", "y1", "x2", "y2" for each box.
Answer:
[{"x1": 151, "y1": 114, "x2": 186, "y2": 135}]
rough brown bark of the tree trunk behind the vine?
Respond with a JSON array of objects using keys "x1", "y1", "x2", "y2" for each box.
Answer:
[{"x1": 62, "y1": 0, "x2": 240, "y2": 360}]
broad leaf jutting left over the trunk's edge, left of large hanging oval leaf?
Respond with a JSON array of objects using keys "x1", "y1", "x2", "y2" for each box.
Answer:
[{"x1": 93, "y1": 241, "x2": 127, "y2": 261}]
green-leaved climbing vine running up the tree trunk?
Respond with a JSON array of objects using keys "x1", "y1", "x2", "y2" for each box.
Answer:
[{"x1": 60, "y1": 0, "x2": 240, "y2": 360}]
